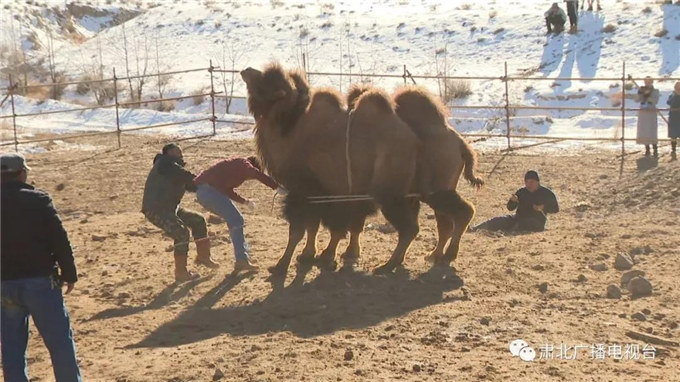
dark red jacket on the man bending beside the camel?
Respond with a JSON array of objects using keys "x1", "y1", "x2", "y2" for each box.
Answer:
[{"x1": 194, "y1": 158, "x2": 278, "y2": 203}]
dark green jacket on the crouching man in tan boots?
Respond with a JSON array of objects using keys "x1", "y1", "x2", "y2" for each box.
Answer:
[{"x1": 142, "y1": 154, "x2": 196, "y2": 214}]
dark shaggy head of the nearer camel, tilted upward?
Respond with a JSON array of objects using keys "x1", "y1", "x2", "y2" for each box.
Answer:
[{"x1": 241, "y1": 63, "x2": 309, "y2": 133}]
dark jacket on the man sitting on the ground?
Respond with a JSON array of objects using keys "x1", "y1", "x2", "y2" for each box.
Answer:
[{"x1": 508, "y1": 186, "x2": 560, "y2": 231}]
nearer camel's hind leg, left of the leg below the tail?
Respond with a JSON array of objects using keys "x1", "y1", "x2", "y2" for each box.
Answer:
[{"x1": 374, "y1": 197, "x2": 420, "y2": 273}]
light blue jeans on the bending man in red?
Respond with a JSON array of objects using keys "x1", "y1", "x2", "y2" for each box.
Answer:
[{"x1": 196, "y1": 184, "x2": 248, "y2": 260}]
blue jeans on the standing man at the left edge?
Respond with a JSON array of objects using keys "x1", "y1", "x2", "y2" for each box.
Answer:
[{"x1": 0, "y1": 277, "x2": 82, "y2": 382}]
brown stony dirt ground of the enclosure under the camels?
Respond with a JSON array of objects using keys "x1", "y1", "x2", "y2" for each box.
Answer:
[{"x1": 1, "y1": 136, "x2": 680, "y2": 382}]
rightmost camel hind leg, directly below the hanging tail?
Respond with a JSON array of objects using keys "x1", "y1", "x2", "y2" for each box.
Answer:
[{"x1": 427, "y1": 190, "x2": 475, "y2": 265}]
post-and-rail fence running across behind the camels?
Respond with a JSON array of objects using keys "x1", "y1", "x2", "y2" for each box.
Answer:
[{"x1": 0, "y1": 61, "x2": 680, "y2": 155}]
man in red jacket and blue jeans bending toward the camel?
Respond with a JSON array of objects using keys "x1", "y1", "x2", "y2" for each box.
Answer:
[{"x1": 194, "y1": 157, "x2": 283, "y2": 272}]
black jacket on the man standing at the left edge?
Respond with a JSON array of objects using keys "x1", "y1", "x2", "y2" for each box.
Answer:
[{"x1": 0, "y1": 181, "x2": 78, "y2": 283}]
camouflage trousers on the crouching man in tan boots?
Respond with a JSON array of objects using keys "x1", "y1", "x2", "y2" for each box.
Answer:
[{"x1": 144, "y1": 207, "x2": 208, "y2": 256}]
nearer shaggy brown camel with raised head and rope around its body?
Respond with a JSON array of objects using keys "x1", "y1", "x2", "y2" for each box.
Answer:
[{"x1": 241, "y1": 64, "x2": 418, "y2": 273}]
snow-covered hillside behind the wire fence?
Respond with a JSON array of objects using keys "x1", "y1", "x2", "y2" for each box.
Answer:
[{"x1": 0, "y1": 0, "x2": 680, "y2": 145}]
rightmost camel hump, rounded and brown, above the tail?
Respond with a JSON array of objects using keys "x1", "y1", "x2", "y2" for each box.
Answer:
[{"x1": 394, "y1": 86, "x2": 448, "y2": 133}]
